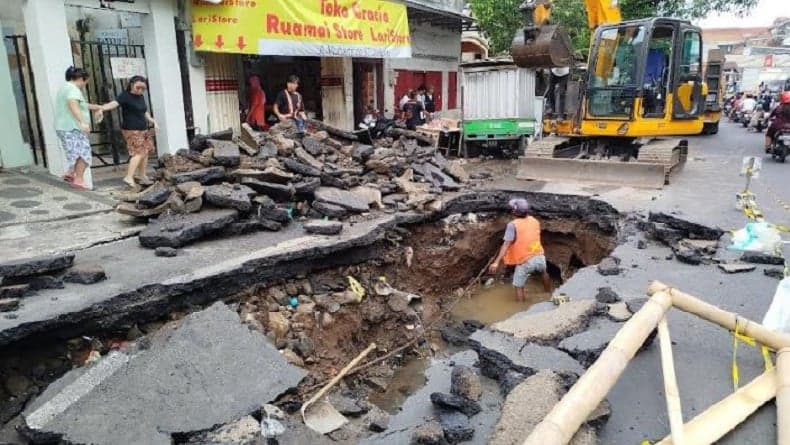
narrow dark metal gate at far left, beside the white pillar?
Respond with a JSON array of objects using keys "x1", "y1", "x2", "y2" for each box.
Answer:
[{"x1": 3, "y1": 35, "x2": 47, "y2": 167}]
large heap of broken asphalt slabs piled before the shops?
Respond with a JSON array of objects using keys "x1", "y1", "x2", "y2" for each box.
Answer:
[{"x1": 116, "y1": 122, "x2": 471, "y2": 248}]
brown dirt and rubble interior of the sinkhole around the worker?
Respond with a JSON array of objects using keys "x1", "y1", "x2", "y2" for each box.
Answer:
[{"x1": 239, "y1": 212, "x2": 618, "y2": 413}]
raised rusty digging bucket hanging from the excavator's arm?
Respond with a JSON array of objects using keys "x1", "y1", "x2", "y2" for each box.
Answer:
[{"x1": 510, "y1": 25, "x2": 573, "y2": 68}]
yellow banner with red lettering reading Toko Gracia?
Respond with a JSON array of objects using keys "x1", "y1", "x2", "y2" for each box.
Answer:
[{"x1": 192, "y1": 0, "x2": 411, "y2": 58}]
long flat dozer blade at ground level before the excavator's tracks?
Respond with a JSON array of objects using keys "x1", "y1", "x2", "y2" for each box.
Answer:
[{"x1": 516, "y1": 157, "x2": 668, "y2": 189}]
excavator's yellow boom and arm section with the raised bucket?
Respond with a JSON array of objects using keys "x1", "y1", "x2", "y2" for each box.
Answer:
[{"x1": 510, "y1": 0, "x2": 622, "y2": 68}]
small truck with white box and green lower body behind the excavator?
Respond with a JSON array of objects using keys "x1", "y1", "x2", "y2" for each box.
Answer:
[{"x1": 461, "y1": 59, "x2": 543, "y2": 156}]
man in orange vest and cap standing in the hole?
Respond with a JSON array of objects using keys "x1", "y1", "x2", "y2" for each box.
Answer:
[{"x1": 488, "y1": 199, "x2": 551, "y2": 301}]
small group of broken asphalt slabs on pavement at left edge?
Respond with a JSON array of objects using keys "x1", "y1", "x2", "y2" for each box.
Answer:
[{"x1": 0, "y1": 253, "x2": 107, "y2": 317}]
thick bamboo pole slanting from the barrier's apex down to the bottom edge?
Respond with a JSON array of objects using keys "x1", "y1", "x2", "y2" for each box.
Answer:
[{"x1": 524, "y1": 292, "x2": 672, "y2": 445}]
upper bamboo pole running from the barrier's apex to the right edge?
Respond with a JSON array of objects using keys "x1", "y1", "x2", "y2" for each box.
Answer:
[{"x1": 647, "y1": 281, "x2": 790, "y2": 351}]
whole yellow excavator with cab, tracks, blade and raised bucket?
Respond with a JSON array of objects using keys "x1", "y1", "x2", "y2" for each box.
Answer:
[{"x1": 511, "y1": 0, "x2": 707, "y2": 188}]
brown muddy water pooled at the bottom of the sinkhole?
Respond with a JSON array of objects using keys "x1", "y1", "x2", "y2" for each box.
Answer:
[{"x1": 370, "y1": 277, "x2": 556, "y2": 414}]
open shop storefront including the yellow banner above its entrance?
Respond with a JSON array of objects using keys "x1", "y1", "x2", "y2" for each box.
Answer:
[{"x1": 191, "y1": 0, "x2": 411, "y2": 131}]
